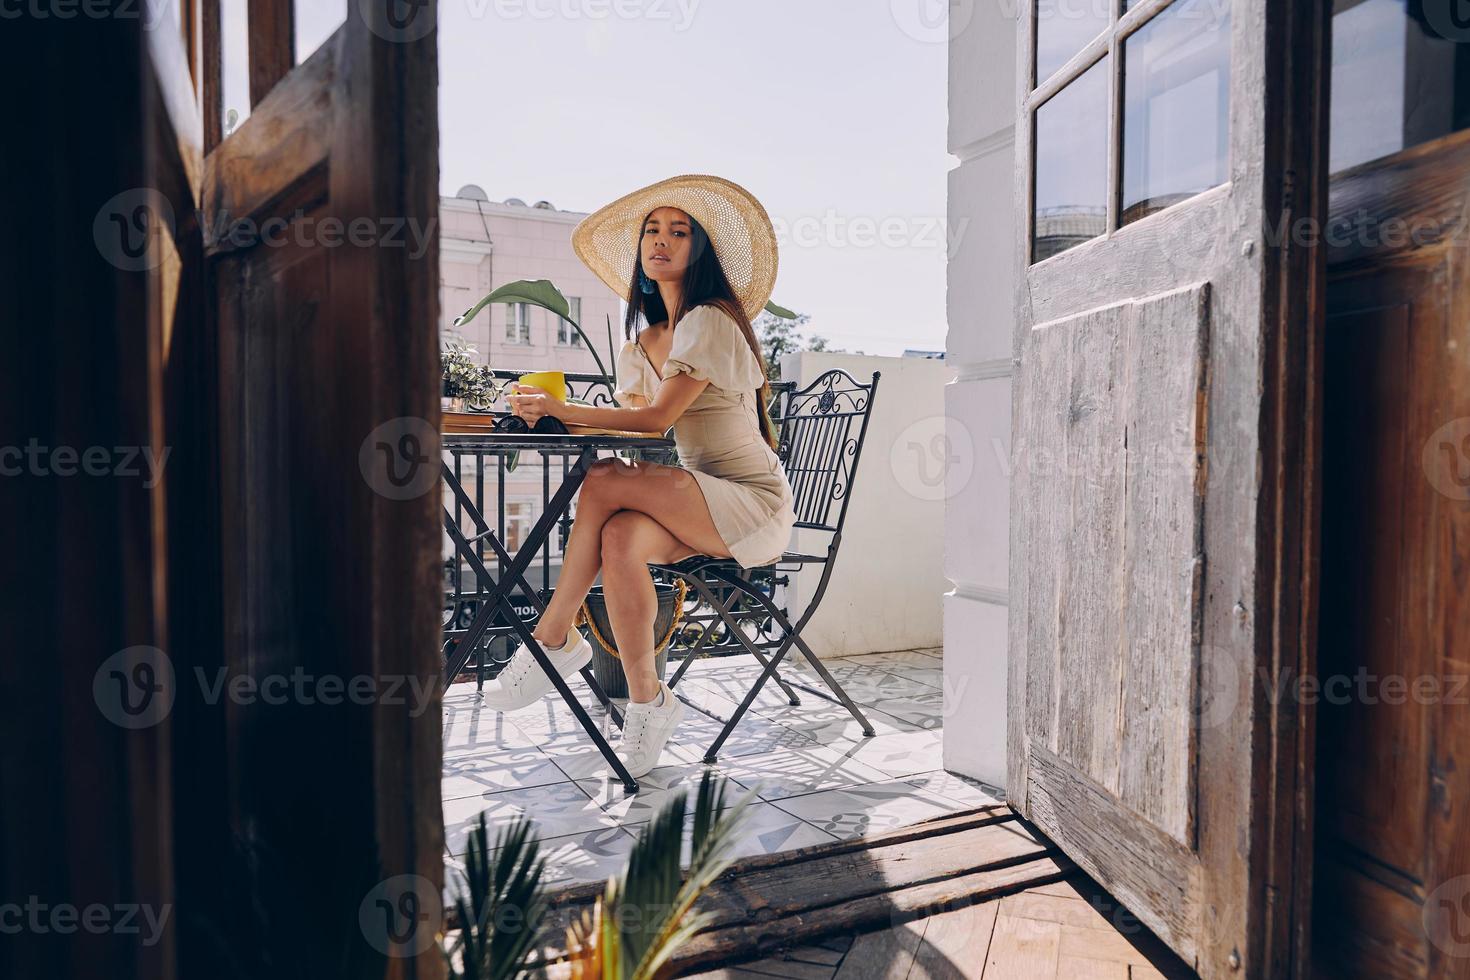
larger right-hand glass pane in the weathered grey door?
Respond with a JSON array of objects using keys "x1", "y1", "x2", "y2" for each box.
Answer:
[{"x1": 1119, "y1": 0, "x2": 1230, "y2": 225}]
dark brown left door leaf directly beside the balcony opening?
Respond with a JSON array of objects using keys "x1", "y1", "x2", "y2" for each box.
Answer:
[{"x1": 201, "y1": 0, "x2": 442, "y2": 976}]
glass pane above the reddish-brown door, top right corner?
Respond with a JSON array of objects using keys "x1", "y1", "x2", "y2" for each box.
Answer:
[{"x1": 1329, "y1": 0, "x2": 1470, "y2": 172}]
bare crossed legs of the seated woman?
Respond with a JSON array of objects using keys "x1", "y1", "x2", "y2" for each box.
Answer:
[{"x1": 534, "y1": 458, "x2": 731, "y2": 701}]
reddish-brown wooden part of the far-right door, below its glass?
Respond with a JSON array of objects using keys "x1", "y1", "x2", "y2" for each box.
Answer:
[{"x1": 1314, "y1": 132, "x2": 1470, "y2": 979}]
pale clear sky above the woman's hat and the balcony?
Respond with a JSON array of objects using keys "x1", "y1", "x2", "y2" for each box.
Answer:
[{"x1": 440, "y1": 0, "x2": 951, "y2": 354}]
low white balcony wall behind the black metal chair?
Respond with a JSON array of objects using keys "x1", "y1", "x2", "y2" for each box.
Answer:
[{"x1": 781, "y1": 351, "x2": 958, "y2": 660}]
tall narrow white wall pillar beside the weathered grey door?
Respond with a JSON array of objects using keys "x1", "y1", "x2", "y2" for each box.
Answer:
[{"x1": 944, "y1": 4, "x2": 1025, "y2": 786}]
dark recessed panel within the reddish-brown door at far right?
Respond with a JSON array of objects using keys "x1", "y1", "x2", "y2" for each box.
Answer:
[{"x1": 1317, "y1": 289, "x2": 1422, "y2": 887}]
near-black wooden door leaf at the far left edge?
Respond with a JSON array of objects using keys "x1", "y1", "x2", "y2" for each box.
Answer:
[{"x1": 0, "y1": 13, "x2": 203, "y2": 980}]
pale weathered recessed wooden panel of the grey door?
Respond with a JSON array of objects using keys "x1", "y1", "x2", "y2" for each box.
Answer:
[{"x1": 1022, "y1": 285, "x2": 1210, "y2": 852}]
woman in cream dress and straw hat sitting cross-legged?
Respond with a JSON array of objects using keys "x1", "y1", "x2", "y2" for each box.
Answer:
[{"x1": 485, "y1": 176, "x2": 795, "y2": 776}]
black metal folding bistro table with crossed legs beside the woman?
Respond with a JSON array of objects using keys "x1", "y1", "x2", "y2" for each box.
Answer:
[{"x1": 441, "y1": 432, "x2": 673, "y2": 793}]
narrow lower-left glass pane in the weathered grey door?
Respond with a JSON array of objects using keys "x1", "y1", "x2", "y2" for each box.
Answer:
[{"x1": 1032, "y1": 57, "x2": 1108, "y2": 262}]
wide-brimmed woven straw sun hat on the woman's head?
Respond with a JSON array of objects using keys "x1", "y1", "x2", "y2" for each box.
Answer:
[{"x1": 572, "y1": 173, "x2": 776, "y2": 320}]
